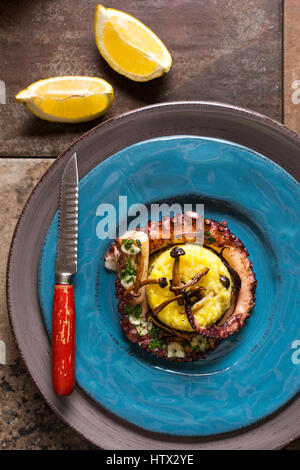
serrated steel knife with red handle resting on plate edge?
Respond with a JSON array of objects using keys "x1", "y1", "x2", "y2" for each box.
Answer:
[{"x1": 52, "y1": 153, "x2": 78, "y2": 395}]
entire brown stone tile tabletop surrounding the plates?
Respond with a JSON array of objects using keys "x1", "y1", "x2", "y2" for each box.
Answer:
[{"x1": 0, "y1": 0, "x2": 300, "y2": 449}]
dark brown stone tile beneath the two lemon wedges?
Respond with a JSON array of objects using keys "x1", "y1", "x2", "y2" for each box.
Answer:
[{"x1": 0, "y1": 0, "x2": 282, "y2": 156}]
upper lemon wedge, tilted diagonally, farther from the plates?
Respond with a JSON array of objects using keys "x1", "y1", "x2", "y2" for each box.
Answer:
[{"x1": 95, "y1": 5, "x2": 172, "y2": 82}]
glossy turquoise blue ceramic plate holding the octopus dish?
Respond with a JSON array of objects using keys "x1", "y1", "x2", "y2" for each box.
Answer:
[{"x1": 39, "y1": 136, "x2": 300, "y2": 436}]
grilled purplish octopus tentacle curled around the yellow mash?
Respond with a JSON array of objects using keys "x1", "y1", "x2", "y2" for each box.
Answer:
[{"x1": 106, "y1": 212, "x2": 256, "y2": 360}]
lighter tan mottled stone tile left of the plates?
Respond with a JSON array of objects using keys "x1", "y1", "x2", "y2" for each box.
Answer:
[{"x1": 0, "y1": 159, "x2": 94, "y2": 450}]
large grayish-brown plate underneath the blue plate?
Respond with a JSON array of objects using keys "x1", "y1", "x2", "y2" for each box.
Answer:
[{"x1": 8, "y1": 102, "x2": 300, "y2": 449}]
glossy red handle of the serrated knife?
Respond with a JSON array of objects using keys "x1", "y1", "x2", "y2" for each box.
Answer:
[{"x1": 52, "y1": 284, "x2": 75, "y2": 395}]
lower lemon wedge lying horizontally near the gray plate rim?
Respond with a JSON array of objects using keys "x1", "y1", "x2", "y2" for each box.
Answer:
[{"x1": 16, "y1": 76, "x2": 114, "y2": 122}]
